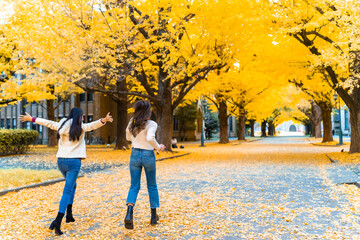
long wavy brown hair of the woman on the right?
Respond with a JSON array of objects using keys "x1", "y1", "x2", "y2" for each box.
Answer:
[{"x1": 129, "y1": 100, "x2": 151, "y2": 137}]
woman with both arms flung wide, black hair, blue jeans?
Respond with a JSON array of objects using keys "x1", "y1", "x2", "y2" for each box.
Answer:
[{"x1": 19, "y1": 108, "x2": 113, "y2": 235}]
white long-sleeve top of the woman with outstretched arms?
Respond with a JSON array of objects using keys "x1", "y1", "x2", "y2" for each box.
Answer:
[{"x1": 35, "y1": 118, "x2": 105, "y2": 158}]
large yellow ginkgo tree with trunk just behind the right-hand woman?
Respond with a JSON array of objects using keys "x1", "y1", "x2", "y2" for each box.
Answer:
[{"x1": 9, "y1": 0, "x2": 268, "y2": 148}]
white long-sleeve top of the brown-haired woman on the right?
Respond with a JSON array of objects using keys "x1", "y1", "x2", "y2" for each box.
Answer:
[{"x1": 126, "y1": 119, "x2": 160, "y2": 150}]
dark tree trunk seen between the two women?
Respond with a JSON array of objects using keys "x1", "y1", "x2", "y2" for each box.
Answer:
[{"x1": 114, "y1": 81, "x2": 128, "y2": 149}]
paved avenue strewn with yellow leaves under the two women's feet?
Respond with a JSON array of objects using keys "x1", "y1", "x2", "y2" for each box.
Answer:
[{"x1": 0, "y1": 138, "x2": 360, "y2": 239}]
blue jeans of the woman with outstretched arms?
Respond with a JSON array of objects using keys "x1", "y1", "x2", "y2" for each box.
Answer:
[{"x1": 58, "y1": 158, "x2": 81, "y2": 213}]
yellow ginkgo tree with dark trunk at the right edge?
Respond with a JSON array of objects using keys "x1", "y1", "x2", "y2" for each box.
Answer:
[{"x1": 267, "y1": 0, "x2": 360, "y2": 153}]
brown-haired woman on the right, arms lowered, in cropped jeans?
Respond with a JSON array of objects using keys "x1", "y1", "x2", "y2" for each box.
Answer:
[{"x1": 124, "y1": 101, "x2": 165, "y2": 229}]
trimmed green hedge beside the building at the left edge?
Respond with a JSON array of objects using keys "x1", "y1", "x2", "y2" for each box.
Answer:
[{"x1": 0, "y1": 129, "x2": 39, "y2": 155}]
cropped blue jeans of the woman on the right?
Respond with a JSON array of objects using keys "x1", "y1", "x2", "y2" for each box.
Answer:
[{"x1": 126, "y1": 148, "x2": 160, "y2": 208}]
